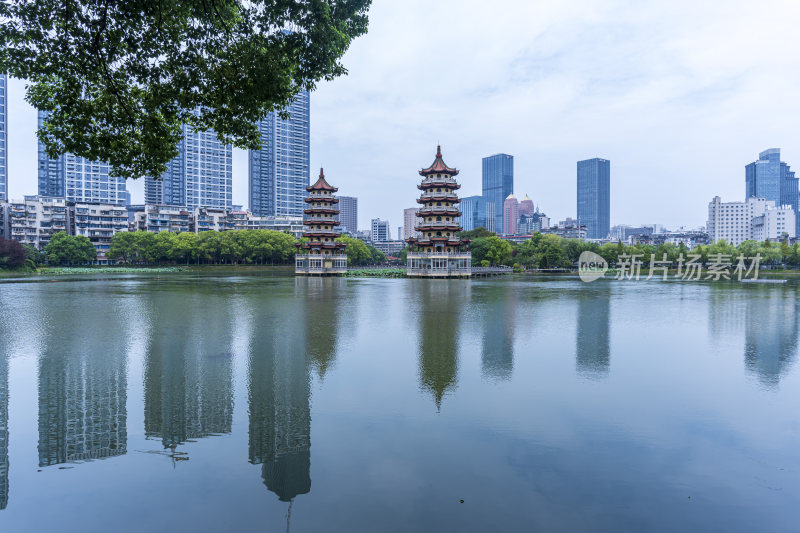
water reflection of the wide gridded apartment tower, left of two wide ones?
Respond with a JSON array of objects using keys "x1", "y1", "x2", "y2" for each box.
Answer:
[{"x1": 39, "y1": 304, "x2": 127, "y2": 466}]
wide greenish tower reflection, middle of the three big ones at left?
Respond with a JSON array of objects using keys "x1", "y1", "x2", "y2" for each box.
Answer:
[{"x1": 144, "y1": 293, "x2": 233, "y2": 460}]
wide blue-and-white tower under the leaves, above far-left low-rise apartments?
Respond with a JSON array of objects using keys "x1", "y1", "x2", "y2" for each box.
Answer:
[{"x1": 38, "y1": 111, "x2": 128, "y2": 205}]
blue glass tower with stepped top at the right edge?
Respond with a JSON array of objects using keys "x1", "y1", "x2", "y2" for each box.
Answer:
[{"x1": 744, "y1": 148, "x2": 800, "y2": 235}]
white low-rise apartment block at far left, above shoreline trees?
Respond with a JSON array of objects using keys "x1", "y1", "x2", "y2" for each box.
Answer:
[{"x1": 7, "y1": 196, "x2": 72, "y2": 250}]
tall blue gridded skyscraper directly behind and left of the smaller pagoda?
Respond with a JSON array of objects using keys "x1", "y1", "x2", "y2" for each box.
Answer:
[{"x1": 248, "y1": 91, "x2": 310, "y2": 217}]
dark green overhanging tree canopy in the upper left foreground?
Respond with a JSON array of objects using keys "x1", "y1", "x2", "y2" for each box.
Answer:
[{"x1": 0, "y1": 0, "x2": 371, "y2": 178}]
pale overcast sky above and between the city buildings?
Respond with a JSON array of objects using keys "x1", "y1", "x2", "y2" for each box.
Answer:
[{"x1": 9, "y1": 0, "x2": 800, "y2": 231}]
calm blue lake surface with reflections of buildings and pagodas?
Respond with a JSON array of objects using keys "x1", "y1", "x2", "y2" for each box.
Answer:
[{"x1": 0, "y1": 273, "x2": 800, "y2": 533}]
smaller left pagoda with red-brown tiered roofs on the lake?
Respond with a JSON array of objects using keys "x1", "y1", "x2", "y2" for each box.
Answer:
[{"x1": 294, "y1": 169, "x2": 347, "y2": 276}]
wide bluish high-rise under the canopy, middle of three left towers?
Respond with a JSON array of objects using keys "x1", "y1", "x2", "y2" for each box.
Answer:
[{"x1": 144, "y1": 126, "x2": 233, "y2": 209}]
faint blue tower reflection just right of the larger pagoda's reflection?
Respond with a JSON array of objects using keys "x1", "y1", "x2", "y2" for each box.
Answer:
[{"x1": 481, "y1": 284, "x2": 518, "y2": 380}]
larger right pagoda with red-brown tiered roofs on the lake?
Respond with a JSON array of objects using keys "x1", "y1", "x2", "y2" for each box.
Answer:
[{"x1": 406, "y1": 146, "x2": 472, "y2": 278}]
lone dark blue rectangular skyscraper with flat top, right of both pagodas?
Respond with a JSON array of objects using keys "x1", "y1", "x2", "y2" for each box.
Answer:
[{"x1": 578, "y1": 157, "x2": 611, "y2": 239}]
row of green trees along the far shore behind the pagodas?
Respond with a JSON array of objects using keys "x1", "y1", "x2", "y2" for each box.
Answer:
[{"x1": 0, "y1": 228, "x2": 800, "y2": 271}]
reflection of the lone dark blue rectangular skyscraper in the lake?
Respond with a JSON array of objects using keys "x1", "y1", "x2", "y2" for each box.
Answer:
[{"x1": 575, "y1": 285, "x2": 611, "y2": 379}]
